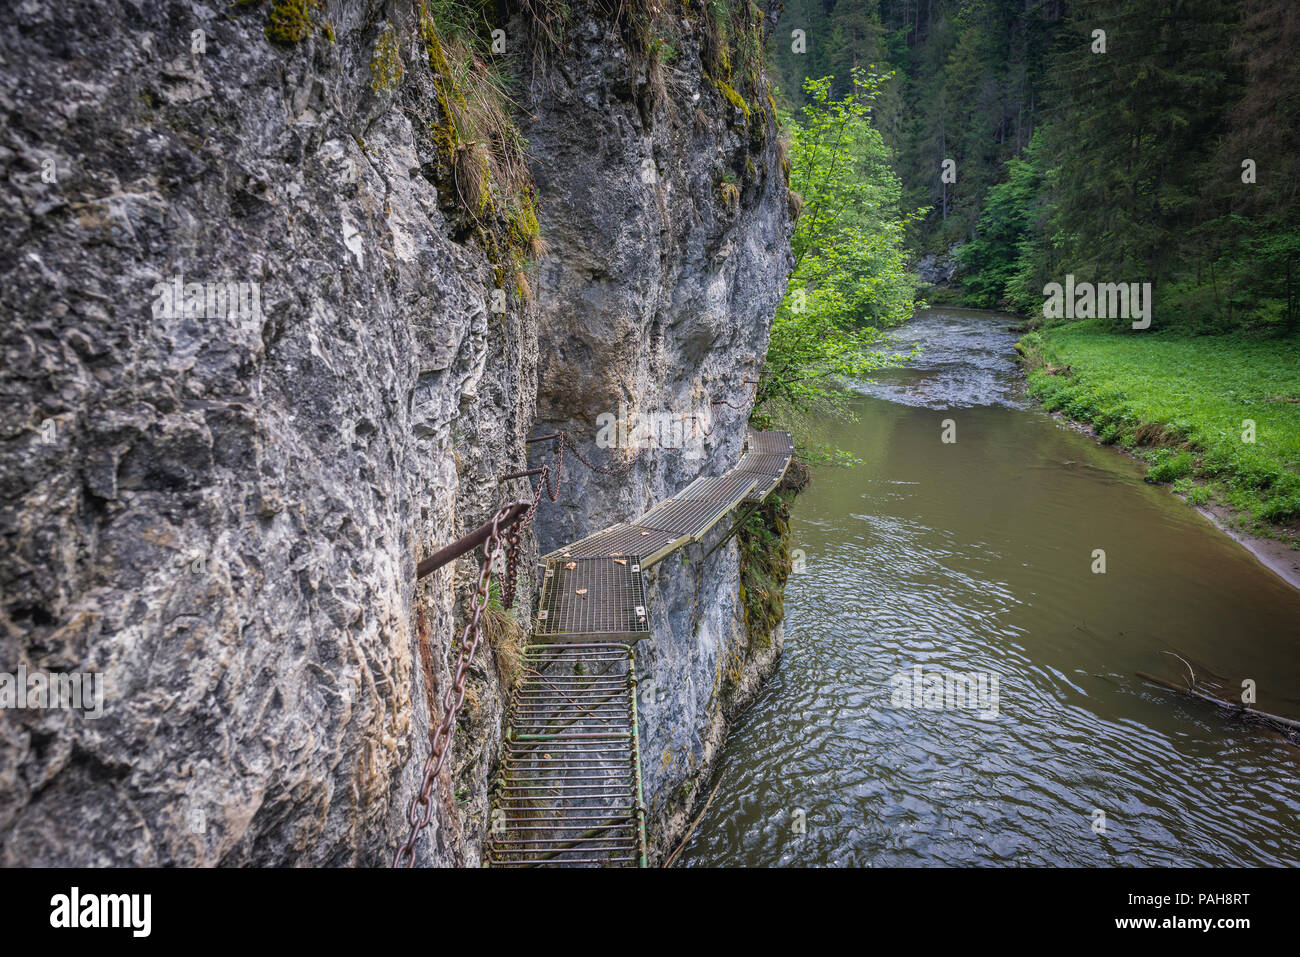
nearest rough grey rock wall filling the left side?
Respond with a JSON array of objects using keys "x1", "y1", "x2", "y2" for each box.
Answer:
[{"x1": 0, "y1": 3, "x2": 537, "y2": 865}]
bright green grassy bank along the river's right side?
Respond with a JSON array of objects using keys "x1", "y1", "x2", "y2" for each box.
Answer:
[{"x1": 1018, "y1": 321, "x2": 1300, "y2": 547}]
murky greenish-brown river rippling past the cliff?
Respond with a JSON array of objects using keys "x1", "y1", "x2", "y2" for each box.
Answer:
[{"x1": 680, "y1": 309, "x2": 1300, "y2": 866}]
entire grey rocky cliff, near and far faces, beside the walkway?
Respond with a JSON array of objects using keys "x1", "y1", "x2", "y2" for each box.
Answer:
[{"x1": 0, "y1": 0, "x2": 789, "y2": 865}]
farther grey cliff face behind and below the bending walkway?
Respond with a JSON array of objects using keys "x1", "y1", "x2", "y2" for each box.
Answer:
[{"x1": 525, "y1": 9, "x2": 792, "y2": 857}]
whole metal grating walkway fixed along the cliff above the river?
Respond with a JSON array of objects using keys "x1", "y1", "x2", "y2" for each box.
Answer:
[{"x1": 488, "y1": 432, "x2": 794, "y2": 867}]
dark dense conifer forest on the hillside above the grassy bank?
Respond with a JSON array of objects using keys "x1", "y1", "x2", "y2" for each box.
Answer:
[{"x1": 768, "y1": 0, "x2": 1300, "y2": 332}]
